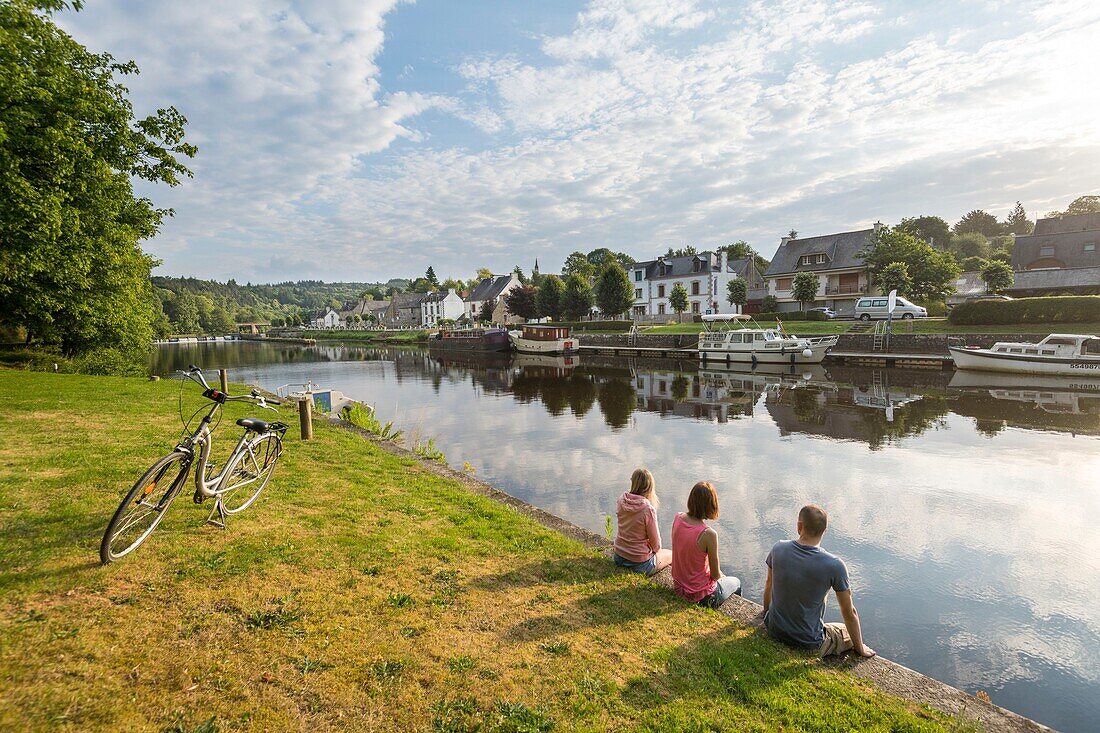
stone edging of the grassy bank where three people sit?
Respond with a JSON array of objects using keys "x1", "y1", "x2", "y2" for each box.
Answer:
[{"x1": 332, "y1": 417, "x2": 1052, "y2": 733}]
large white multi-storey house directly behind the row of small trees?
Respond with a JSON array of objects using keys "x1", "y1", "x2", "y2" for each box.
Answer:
[{"x1": 628, "y1": 251, "x2": 755, "y2": 318}]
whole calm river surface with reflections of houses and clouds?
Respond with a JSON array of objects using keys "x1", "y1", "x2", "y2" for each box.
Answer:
[{"x1": 152, "y1": 342, "x2": 1100, "y2": 731}]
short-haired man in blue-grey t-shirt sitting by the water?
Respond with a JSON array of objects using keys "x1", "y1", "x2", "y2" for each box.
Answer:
[{"x1": 763, "y1": 504, "x2": 875, "y2": 657}]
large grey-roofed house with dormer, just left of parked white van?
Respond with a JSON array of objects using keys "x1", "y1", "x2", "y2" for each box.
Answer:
[{"x1": 763, "y1": 222, "x2": 882, "y2": 315}]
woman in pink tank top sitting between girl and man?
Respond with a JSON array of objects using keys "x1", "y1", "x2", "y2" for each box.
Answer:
[{"x1": 672, "y1": 481, "x2": 741, "y2": 609}]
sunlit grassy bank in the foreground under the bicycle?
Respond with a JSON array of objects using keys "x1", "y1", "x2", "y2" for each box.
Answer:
[{"x1": 0, "y1": 371, "x2": 952, "y2": 731}]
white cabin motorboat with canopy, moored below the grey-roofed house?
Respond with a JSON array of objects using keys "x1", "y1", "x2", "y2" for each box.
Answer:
[{"x1": 699, "y1": 314, "x2": 839, "y2": 364}]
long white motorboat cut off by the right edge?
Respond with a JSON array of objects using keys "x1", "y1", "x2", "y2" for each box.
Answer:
[{"x1": 947, "y1": 333, "x2": 1100, "y2": 376}]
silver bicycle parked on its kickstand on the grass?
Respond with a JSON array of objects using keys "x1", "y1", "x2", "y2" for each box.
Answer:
[{"x1": 99, "y1": 364, "x2": 289, "y2": 565}]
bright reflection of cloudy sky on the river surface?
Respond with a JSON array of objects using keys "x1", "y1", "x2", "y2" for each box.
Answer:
[{"x1": 193, "y1": 354, "x2": 1100, "y2": 722}]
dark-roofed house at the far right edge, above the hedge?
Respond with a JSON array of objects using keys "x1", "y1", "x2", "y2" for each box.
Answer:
[{"x1": 1012, "y1": 214, "x2": 1100, "y2": 271}]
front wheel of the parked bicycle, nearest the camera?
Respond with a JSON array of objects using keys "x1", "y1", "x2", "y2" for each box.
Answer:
[{"x1": 99, "y1": 450, "x2": 191, "y2": 565}]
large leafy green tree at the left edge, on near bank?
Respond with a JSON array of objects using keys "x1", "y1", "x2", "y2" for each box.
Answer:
[{"x1": 0, "y1": 0, "x2": 196, "y2": 353}]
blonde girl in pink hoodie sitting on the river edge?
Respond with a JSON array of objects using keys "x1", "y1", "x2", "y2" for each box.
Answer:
[{"x1": 615, "y1": 469, "x2": 672, "y2": 576}]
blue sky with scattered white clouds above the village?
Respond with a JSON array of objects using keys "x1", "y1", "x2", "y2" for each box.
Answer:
[{"x1": 57, "y1": 0, "x2": 1100, "y2": 283}]
